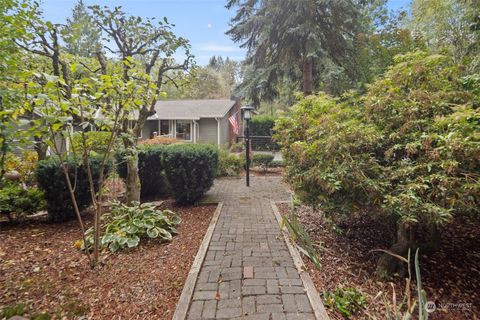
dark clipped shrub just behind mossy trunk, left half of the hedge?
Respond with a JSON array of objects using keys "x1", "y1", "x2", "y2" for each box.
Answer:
[{"x1": 115, "y1": 145, "x2": 170, "y2": 199}]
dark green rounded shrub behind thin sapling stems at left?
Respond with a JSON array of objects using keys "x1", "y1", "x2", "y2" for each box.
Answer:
[{"x1": 36, "y1": 157, "x2": 111, "y2": 222}]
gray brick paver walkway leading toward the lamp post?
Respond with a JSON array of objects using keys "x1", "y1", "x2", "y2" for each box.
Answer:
[{"x1": 187, "y1": 177, "x2": 315, "y2": 320}]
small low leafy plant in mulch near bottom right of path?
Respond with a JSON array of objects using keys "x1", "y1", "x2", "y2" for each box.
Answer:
[{"x1": 323, "y1": 286, "x2": 368, "y2": 319}]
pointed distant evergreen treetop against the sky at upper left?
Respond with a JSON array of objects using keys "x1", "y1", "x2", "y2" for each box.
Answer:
[{"x1": 63, "y1": 0, "x2": 101, "y2": 57}]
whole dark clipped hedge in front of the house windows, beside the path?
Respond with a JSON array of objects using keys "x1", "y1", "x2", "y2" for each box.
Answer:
[{"x1": 116, "y1": 144, "x2": 219, "y2": 204}]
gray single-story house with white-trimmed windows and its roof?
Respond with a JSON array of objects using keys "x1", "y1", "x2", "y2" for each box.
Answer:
[{"x1": 140, "y1": 99, "x2": 241, "y2": 145}]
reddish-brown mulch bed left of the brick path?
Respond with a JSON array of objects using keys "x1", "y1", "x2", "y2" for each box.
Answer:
[{"x1": 0, "y1": 202, "x2": 215, "y2": 319}]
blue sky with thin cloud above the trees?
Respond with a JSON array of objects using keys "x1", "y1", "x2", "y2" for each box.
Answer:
[{"x1": 41, "y1": 0, "x2": 410, "y2": 65}]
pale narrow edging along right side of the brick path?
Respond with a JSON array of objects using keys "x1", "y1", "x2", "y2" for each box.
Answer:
[{"x1": 270, "y1": 201, "x2": 330, "y2": 320}]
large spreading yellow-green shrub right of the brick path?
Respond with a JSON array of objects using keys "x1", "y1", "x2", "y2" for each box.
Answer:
[{"x1": 276, "y1": 52, "x2": 480, "y2": 271}]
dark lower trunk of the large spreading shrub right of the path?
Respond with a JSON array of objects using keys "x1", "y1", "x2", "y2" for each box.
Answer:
[{"x1": 376, "y1": 221, "x2": 416, "y2": 279}]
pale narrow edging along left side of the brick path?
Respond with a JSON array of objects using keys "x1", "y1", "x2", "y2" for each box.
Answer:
[{"x1": 172, "y1": 202, "x2": 223, "y2": 320}]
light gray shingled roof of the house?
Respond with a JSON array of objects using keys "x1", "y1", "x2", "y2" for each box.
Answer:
[{"x1": 148, "y1": 99, "x2": 236, "y2": 120}]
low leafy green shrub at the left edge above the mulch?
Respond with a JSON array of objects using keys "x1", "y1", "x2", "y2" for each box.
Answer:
[{"x1": 0, "y1": 182, "x2": 45, "y2": 221}]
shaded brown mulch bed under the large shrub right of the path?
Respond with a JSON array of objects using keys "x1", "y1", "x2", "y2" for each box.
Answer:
[{"x1": 278, "y1": 204, "x2": 480, "y2": 320}]
